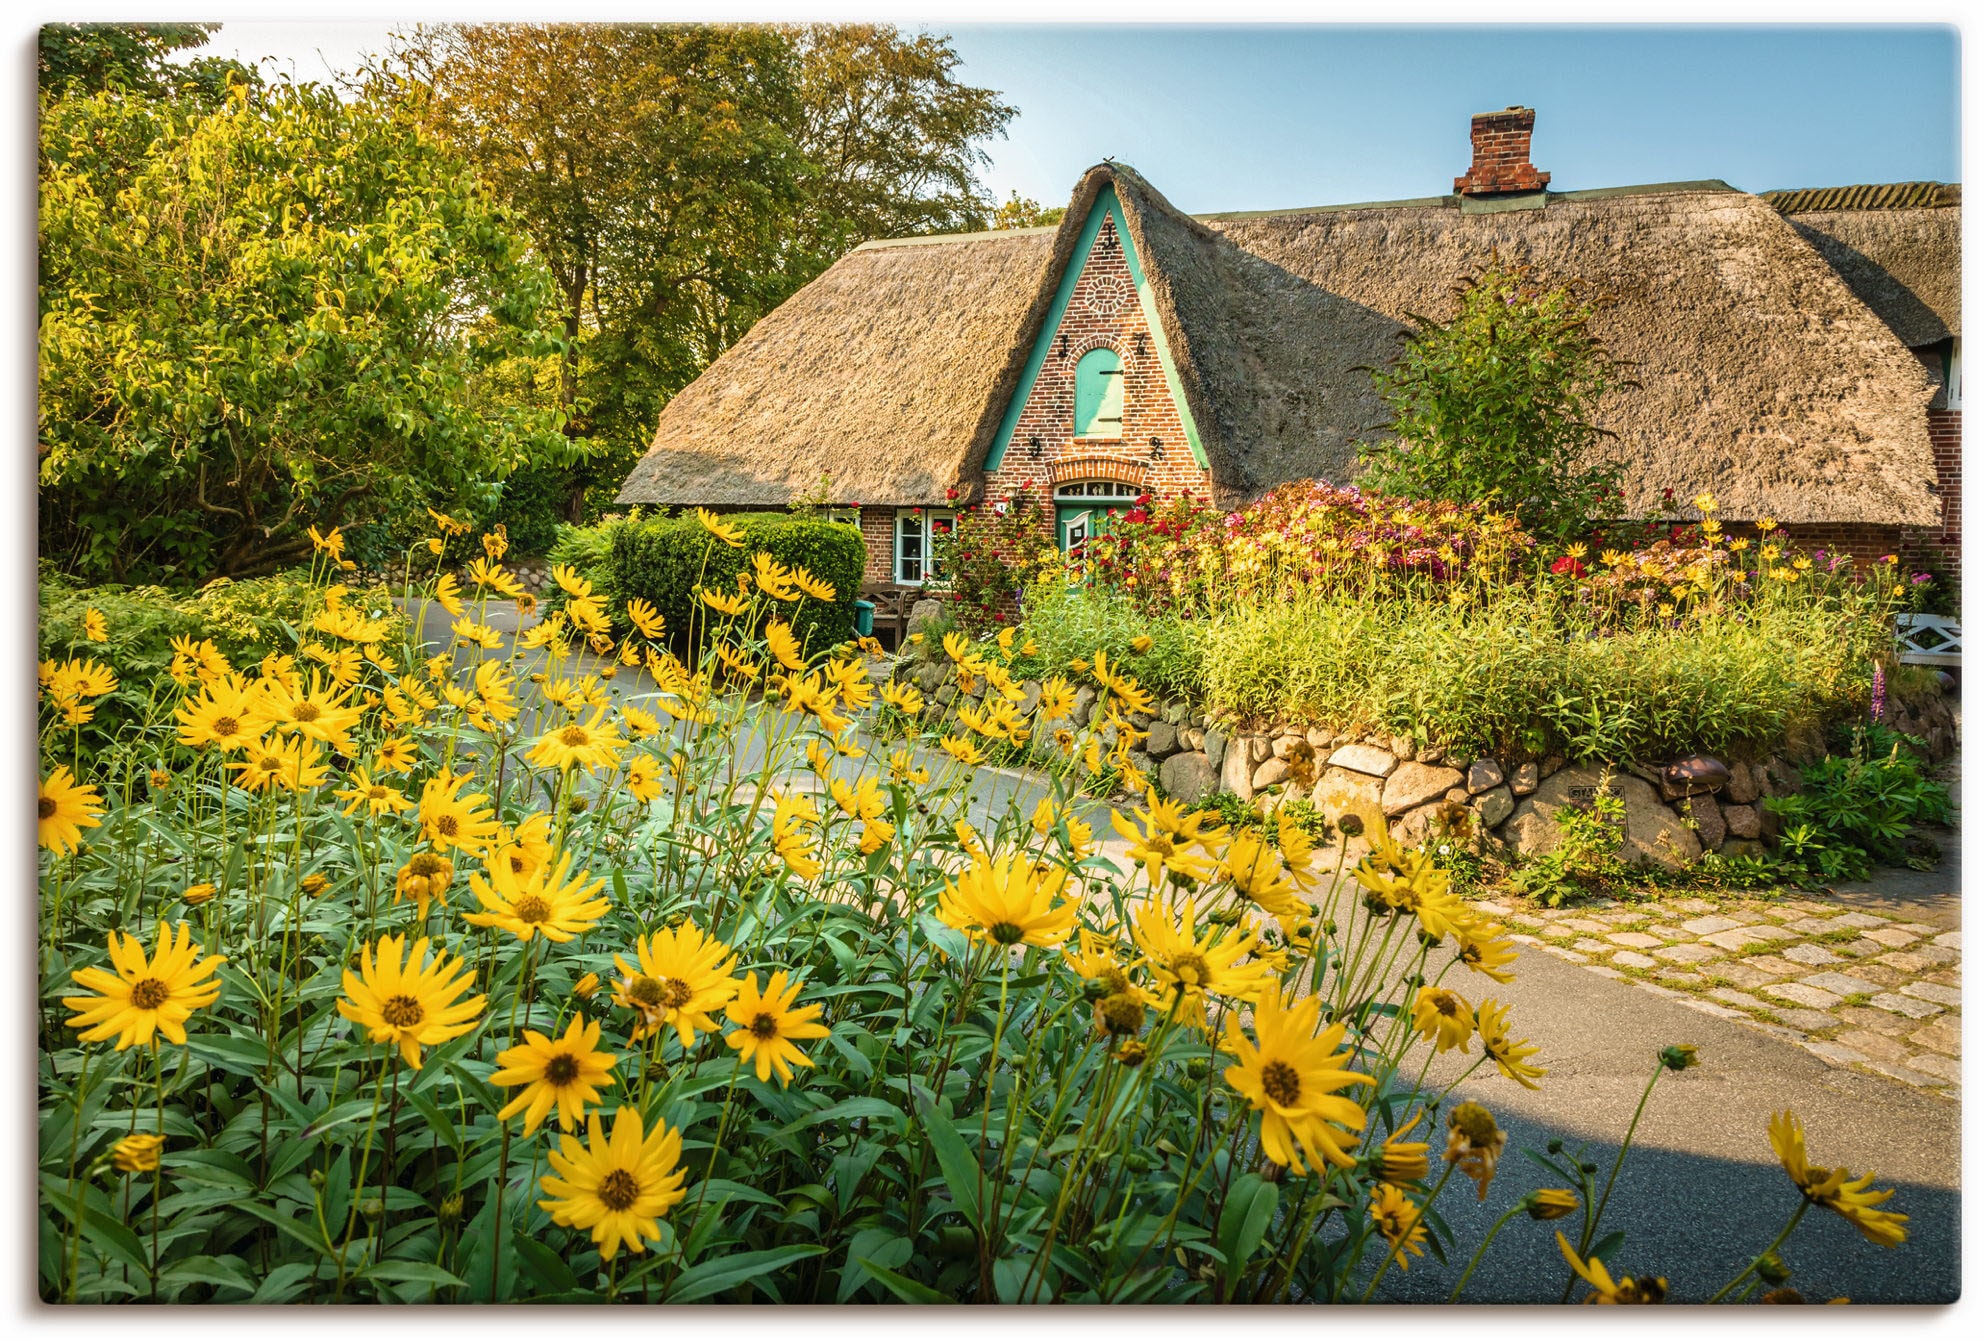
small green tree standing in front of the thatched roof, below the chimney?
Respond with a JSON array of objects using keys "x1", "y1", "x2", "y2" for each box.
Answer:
[{"x1": 1361, "y1": 256, "x2": 1633, "y2": 540}]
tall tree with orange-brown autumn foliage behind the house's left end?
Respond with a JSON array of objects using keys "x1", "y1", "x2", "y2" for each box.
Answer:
[{"x1": 381, "y1": 24, "x2": 1014, "y2": 538}]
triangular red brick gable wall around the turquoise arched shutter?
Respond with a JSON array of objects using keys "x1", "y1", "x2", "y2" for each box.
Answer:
[{"x1": 984, "y1": 207, "x2": 1212, "y2": 540}]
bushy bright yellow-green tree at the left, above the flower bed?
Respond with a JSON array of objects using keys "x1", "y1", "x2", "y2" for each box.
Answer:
[{"x1": 40, "y1": 83, "x2": 569, "y2": 580}]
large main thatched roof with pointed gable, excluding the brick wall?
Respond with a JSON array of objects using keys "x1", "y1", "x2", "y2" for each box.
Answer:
[{"x1": 621, "y1": 163, "x2": 1938, "y2": 524}]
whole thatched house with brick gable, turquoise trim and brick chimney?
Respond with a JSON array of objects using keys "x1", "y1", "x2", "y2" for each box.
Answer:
[{"x1": 621, "y1": 109, "x2": 1956, "y2": 582}]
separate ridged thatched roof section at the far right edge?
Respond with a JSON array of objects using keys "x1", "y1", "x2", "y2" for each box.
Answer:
[{"x1": 1760, "y1": 183, "x2": 1962, "y2": 347}]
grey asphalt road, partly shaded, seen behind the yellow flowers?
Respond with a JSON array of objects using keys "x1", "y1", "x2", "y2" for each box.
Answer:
[{"x1": 410, "y1": 605, "x2": 1962, "y2": 1304}]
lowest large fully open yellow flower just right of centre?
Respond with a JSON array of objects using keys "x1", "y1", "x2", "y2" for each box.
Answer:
[{"x1": 1226, "y1": 993, "x2": 1371, "y2": 1173}]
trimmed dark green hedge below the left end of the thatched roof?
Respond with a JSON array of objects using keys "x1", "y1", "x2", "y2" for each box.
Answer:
[{"x1": 605, "y1": 512, "x2": 867, "y2": 651}]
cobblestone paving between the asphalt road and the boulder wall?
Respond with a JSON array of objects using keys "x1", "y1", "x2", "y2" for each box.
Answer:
[{"x1": 1474, "y1": 897, "x2": 1962, "y2": 1100}]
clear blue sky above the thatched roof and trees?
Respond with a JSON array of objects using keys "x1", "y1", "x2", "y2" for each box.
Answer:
[{"x1": 178, "y1": 22, "x2": 1960, "y2": 212}]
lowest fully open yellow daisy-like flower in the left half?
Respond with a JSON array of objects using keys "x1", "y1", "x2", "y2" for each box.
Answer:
[{"x1": 538, "y1": 1106, "x2": 688, "y2": 1263}]
